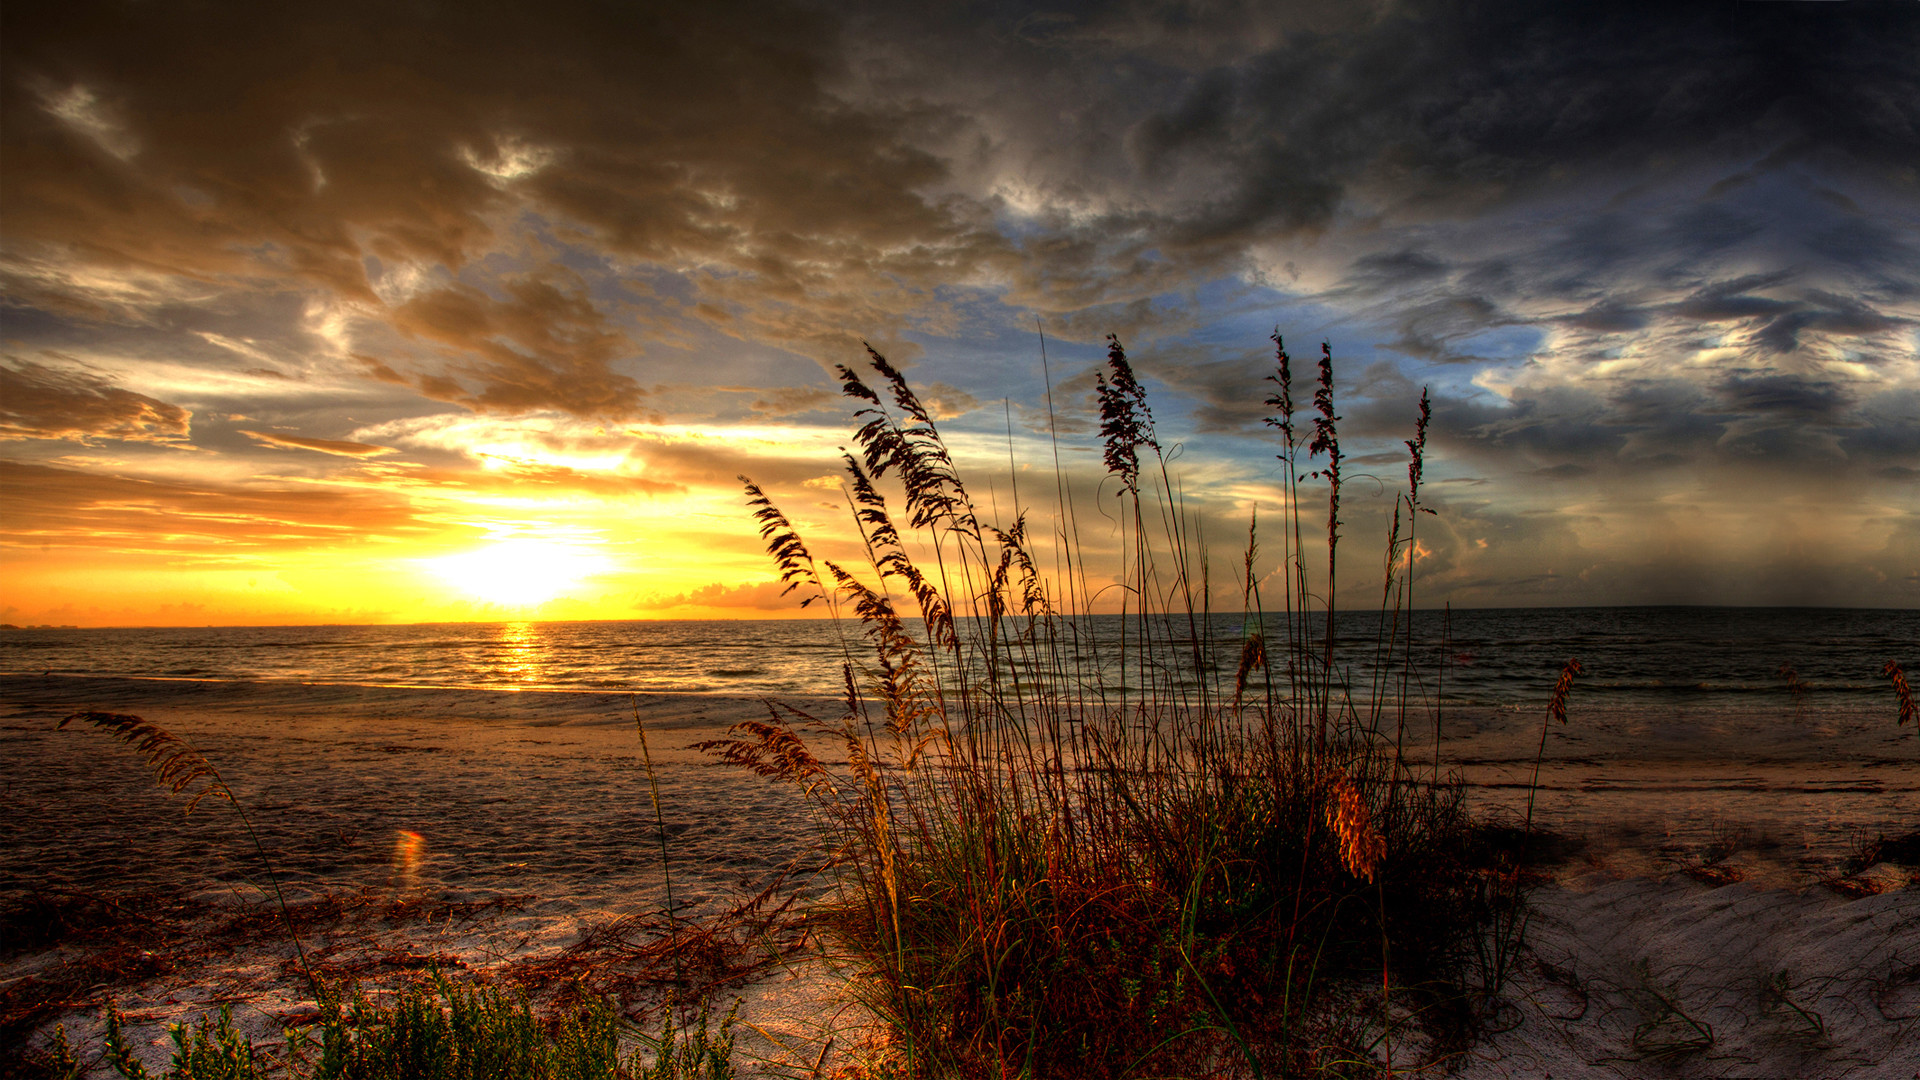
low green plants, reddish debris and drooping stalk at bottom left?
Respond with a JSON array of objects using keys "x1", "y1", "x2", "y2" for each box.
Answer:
[{"x1": 31, "y1": 711, "x2": 748, "y2": 1080}]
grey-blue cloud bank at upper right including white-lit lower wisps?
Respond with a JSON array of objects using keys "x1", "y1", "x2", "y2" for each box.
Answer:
[{"x1": 900, "y1": 2, "x2": 1920, "y2": 467}]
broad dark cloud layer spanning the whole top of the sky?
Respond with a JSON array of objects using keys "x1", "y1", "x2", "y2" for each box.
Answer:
[{"x1": 0, "y1": 0, "x2": 1920, "y2": 363}]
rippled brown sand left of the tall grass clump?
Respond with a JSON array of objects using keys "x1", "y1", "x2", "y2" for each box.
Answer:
[{"x1": 0, "y1": 678, "x2": 848, "y2": 1053}]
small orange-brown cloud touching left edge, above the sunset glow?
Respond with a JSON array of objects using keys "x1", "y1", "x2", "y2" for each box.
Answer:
[{"x1": 0, "y1": 357, "x2": 192, "y2": 444}]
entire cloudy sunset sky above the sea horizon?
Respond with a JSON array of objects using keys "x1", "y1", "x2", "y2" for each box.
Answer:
[{"x1": 0, "y1": 0, "x2": 1920, "y2": 625}]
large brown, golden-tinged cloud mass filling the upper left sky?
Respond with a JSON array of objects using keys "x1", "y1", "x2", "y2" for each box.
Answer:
[{"x1": 0, "y1": 0, "x2": 1000, "y2": 415}]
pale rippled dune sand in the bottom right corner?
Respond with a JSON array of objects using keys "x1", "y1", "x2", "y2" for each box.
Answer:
[{"x1": 1461, "y1": 872, "x2": 1920, "y2": 1080}]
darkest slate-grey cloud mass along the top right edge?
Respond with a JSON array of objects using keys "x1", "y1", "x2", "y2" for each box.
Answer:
[{"x1": 897, "y1": 2, "x2": 1920, "y2": 244}]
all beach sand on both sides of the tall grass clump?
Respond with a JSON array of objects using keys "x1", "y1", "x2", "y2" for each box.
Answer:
[{"x1": 0, "y1": 676, "x2": 1920, "y2": 1076}]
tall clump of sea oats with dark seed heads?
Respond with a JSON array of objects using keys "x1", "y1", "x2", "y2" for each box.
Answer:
[{"x1": 703, "y1": 336, "x2": 1519, "y2": 1078}]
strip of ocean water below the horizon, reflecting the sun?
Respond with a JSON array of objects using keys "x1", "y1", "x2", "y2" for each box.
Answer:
[{"x1": 0, "y1": 607, "x2": 1920, "y2": 711}]
